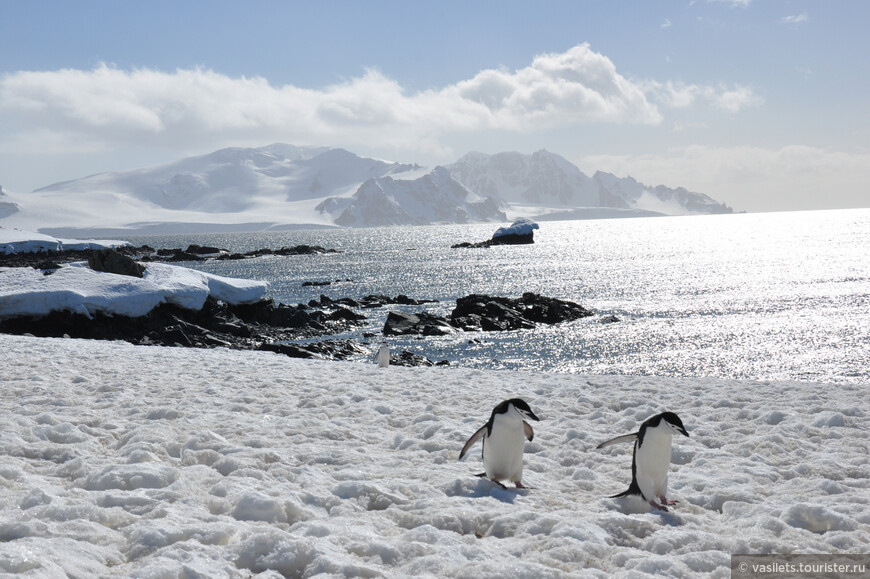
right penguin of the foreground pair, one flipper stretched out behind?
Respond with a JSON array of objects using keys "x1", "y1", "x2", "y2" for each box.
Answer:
[{"x1": 596, "y1": 412, "x2": 689, "y2": 511}]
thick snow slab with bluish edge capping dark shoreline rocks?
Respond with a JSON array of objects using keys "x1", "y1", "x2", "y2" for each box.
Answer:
[{"x1": 0, "y1": 262, "x2": 268, "y2": 319}]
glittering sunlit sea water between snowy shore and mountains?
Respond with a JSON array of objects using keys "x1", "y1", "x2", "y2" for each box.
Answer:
[{"x1": 122, "y1": 209, "x2": 870, "y2": 383}]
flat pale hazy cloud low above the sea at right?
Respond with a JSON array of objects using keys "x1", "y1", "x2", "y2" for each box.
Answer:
[{"x1": 578, "y1": 145, "x2": 870, "y2": 211}]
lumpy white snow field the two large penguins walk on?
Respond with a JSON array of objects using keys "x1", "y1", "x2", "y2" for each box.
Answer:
[{"x1": 0, "y1": 335, "x2": 870, "y2": 577}]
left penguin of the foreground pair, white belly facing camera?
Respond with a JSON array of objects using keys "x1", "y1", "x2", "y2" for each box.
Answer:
[{"x1": 459, "y1": 398, "x2": 539, "y2": 489}]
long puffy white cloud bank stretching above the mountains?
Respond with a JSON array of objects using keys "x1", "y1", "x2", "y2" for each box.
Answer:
[{"x1": 0, "y1": 44, "x2": 662, "y2": 157}]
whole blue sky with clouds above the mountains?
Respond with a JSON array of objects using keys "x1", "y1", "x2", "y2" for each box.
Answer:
[{"x1": 0, "y1": 0, "x2": 870, "y2": 212}]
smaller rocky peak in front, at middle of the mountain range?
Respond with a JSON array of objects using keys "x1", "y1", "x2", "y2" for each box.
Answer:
[{"x1": 317, "y1": 167, "x2": 507, "y2": 227}]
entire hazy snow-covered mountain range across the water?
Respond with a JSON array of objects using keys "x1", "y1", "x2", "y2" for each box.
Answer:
[{"x1": 0, "y1": 143, "x2": 731, "y2": 237}]
